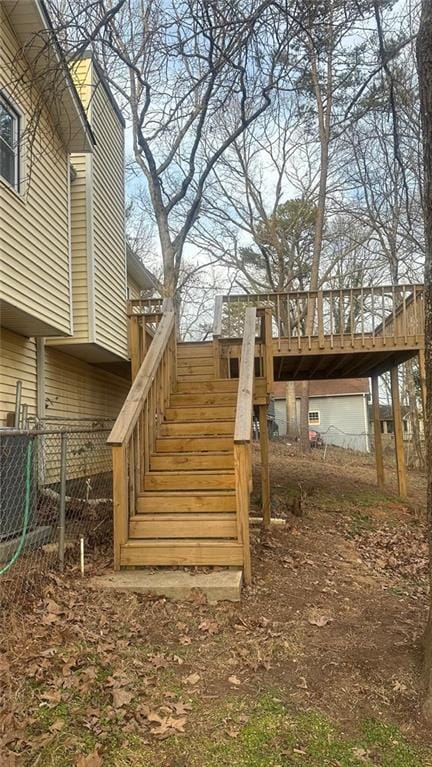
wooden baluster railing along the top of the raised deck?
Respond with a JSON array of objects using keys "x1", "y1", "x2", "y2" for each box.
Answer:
[{"x1": 218, "y1": 284, "x2": 424, "y2": 350}]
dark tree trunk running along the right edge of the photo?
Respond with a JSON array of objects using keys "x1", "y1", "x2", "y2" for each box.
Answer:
[{"x1": 417, "y1": 0, "x2": 432, "y2": 721}]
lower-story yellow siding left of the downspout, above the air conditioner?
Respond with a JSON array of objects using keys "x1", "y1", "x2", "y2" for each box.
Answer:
[{"x1": 0, "y1": 328, "x2": 36, "y2": 426}]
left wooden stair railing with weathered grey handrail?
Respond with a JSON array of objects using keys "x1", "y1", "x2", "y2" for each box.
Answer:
[{"x1": 107, "y1": 304, "x2": 176, "y2": 570}]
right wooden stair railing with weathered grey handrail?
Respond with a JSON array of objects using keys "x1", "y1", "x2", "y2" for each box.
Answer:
[{"x1": 234, "y1": 307, "x2": 257, "y2": 583}]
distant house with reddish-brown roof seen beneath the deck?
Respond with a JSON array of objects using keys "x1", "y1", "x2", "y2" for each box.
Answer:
[{"x1": 273, "y1": 378, "x2": 370, "y2": 452}]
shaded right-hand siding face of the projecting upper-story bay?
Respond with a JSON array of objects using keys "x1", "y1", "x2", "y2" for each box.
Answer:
[{"x1": 91, "y1": 84, "x2": 127, "y2": 358}]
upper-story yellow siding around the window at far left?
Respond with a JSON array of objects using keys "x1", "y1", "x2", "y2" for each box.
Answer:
[{"x1": 0, "y1": 4, "x2": 72, "y2": 335}]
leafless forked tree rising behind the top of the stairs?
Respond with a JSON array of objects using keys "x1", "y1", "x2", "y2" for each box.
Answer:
[{"x1": 48, "y1": 0, "x2": 295, "y2": 295}]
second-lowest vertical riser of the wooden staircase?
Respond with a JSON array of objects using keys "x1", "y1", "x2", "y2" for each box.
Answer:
[{"x1": 129, "y1": 514, "x2": 237, "y2": 539}]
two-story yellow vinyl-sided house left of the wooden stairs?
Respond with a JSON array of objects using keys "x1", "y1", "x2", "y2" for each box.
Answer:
[{"x1": 0, "y1": 0, "x2": 154, "y2": 426}]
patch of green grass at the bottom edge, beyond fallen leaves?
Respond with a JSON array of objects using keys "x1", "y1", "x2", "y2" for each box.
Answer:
[{"x1": 107, "y1": 695, "x2": 432, "y2": 767}]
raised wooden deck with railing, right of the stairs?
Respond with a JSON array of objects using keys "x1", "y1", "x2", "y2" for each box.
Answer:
[{"x1": 218, "y1": 285, "x2": 424, "y2": 381}]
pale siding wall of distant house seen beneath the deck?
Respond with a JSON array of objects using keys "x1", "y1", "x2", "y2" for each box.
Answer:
[{"x1": 275, "y1": 394, "x2": 370, "y2": 452}]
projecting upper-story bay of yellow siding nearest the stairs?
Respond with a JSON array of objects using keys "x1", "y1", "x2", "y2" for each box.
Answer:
[{"x1": 48, "y1": 58, "x2": 128, "y2": 362}]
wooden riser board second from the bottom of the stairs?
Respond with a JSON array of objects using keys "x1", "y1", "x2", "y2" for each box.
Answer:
[{"x1": 129, "y1": 513, "x2": 237, "y2": 538}]
